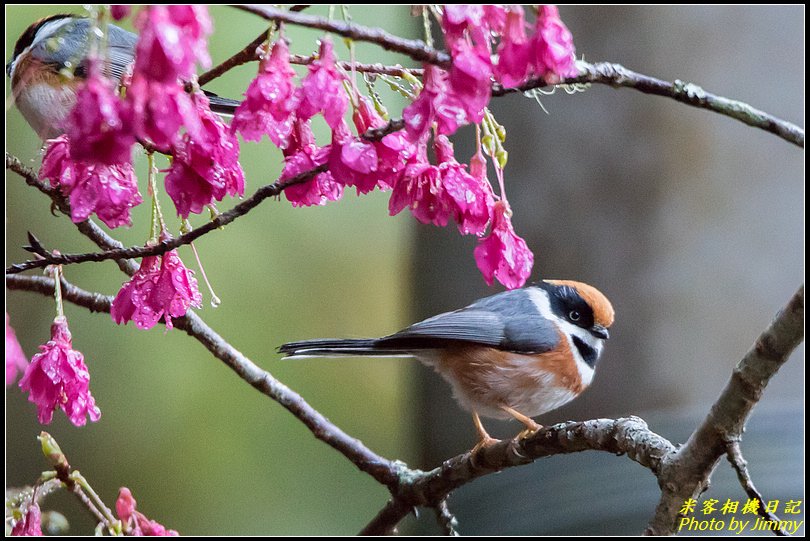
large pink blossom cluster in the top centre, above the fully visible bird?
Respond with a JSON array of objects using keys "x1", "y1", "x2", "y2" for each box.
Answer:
[{"x1": 231, "y1": 5, "x2": 577, "y2": 288}]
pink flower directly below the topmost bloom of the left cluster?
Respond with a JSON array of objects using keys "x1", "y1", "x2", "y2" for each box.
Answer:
[{"x1": 127, "y1": 77, "x2": 201, "y2": 152}]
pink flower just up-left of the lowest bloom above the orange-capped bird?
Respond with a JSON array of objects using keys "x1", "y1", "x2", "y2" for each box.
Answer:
[{"x1": 434, "y1": 135, "x2": 494, "y2": 235}]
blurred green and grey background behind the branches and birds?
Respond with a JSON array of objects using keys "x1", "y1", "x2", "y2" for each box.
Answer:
[{"x1": 6, "y1": 6, "x2": 804, "y2": 534}]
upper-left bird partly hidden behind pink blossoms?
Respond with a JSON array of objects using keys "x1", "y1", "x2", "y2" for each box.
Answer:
[{"x1": 6, "y1": 13, "x2": 239, "y2": 139}]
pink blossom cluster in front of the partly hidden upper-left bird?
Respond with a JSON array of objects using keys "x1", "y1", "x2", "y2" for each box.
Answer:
[{"x1": 40, "y1": 5, "x2": 245, "y2": 227}]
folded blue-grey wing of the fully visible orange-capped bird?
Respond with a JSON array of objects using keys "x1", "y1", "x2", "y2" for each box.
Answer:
[{"x1": 377, "y1": 291, "x2": 559, "y2": 353}]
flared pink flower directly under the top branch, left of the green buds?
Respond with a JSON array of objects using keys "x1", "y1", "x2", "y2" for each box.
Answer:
[{"x1": 402, "y1": 65, "x2": 468, "y2": 142}]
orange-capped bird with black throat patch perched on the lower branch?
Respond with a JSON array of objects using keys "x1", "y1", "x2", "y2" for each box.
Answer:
[{"x1": 278, "y1": 280, "x2": 614, "y2": 448}]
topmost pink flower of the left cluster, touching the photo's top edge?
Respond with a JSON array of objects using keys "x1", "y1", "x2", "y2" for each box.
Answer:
[{"x1": 134, "y1": 5, "x2": 213, "y2": 84}]
